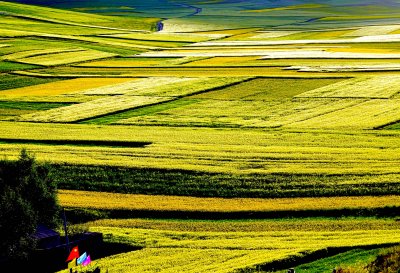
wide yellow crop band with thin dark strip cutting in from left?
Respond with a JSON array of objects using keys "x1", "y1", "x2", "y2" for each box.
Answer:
[{"x1": 0, "y1": 121, "x2": 399, "y2": 176}]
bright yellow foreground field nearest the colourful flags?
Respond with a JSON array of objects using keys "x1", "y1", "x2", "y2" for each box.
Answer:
[{"x1": 54, "y1": 219, "x2": 400, "y2": 272}]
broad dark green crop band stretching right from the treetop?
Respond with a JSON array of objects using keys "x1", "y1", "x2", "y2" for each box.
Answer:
[{"x1": 50, "y1": 162, "x2": 400, "y2": 198}]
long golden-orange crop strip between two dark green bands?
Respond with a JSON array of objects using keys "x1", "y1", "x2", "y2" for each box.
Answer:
[{"x1": 58, "y1": 190, "x2": 400, "y2": 212}]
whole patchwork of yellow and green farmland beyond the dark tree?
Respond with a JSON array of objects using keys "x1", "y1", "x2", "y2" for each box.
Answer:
[{"x1": 0, "y1": 0, "x2": 400, "y2": 273}]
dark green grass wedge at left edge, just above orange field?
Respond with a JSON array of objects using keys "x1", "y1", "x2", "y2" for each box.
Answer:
[{"x1": 0, "y1": 74, "x2": 62, "y2": 91}]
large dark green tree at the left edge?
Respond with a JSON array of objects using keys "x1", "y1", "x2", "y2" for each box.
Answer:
[{"x1": 0, "y1": 150, "x2": 59, "y2": 259}]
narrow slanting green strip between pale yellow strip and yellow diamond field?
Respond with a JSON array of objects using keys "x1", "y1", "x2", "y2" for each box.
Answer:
[{"x1": 79, "y1": 99, "x2": 198, "y2": 125}]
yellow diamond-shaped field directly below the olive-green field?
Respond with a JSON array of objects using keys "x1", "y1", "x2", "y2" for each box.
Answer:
[{"x1": 118, "y1": 99, "x2": 364, "y2": 128}]
